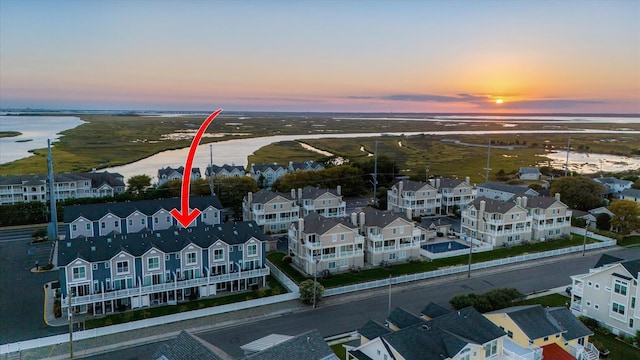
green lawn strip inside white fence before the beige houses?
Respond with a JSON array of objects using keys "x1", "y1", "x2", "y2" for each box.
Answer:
[{"x1": 267, "y1": 235, "x2": 597, "y2": 288}]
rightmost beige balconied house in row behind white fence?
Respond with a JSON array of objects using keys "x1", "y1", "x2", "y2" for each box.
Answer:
[{"x1": 516, "y1": 194, "x2": 572, "y2": 241}]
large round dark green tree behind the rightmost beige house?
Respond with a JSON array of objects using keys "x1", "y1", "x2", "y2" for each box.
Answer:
[{"x1": 551, "y1": 176, "x2": 604, "y2": 211}]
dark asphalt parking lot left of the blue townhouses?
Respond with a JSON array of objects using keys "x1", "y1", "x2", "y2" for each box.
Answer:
[{"x1": 0, "y1": 228, "x2": 65, "y2": 344}]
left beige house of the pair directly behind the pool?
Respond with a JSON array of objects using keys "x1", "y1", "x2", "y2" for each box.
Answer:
[{"x1": 387, "y1": 180, "x2": 442, "y2": 218}]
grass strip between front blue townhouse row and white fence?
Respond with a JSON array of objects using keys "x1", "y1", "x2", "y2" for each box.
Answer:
[{"x1": 85, "y1": 275, "x2": 287, "y2": 330}]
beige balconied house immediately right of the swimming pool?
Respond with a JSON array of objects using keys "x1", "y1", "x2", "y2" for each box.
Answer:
[{"x1": 460, "y1": 197, "x2": 533, "y2": 247}]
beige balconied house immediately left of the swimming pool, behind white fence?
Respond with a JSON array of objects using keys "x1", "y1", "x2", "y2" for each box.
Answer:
[{"x1": 351, "y1": 206, "x2": 426, "y2": 265}]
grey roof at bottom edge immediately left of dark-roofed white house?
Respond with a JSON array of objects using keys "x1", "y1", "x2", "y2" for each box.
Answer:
[{"x1": 241, "y1": 329, "x2": 339, "y2": 360}]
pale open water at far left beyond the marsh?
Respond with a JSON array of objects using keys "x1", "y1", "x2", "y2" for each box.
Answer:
[{"x1": 0, "y1": 116, "x2": 84, "y2": 164}]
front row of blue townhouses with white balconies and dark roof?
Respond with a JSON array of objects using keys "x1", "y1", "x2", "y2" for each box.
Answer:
[{"x1": 58, "y1": 221, "x2": 269, "y2": 315}]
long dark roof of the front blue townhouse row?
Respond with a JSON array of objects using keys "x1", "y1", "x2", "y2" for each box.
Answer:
[{"x1": 58, "y1": 221, "x2": 268, "y2": 266}]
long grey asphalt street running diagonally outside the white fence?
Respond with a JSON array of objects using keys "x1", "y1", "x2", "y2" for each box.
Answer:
[{"x1": 91, "y1": 248, "x2": 640, "y2": 360}]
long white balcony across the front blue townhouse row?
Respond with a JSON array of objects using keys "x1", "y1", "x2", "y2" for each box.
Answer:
[{"x1": 61, "y1": 267, "x2": 270, "y2": 307}]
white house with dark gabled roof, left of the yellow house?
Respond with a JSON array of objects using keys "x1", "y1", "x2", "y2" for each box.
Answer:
[{"x1": 347, "y1": 307, "x2": 534, "y2": 360}]
